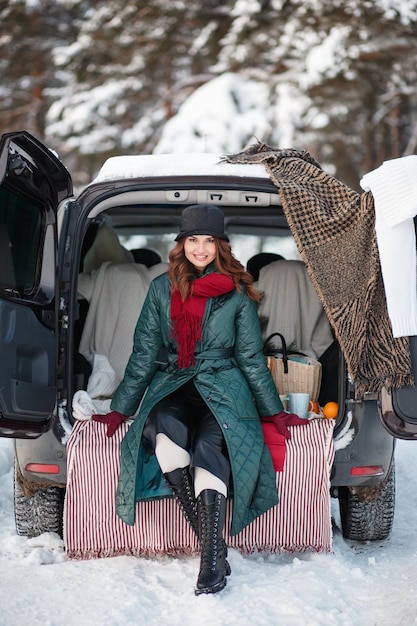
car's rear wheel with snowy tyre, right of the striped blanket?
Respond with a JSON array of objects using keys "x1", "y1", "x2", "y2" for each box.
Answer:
[{"x1": 338, "y1": 461, "x2": 395, "y2": 541}]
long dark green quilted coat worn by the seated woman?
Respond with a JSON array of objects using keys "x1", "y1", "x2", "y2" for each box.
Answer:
[{"x1": 111, "y1": 266, "x2": 283, "y2": 535}]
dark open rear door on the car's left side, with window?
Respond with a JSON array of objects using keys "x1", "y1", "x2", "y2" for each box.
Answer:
[{"x1": 0, "y1": 131, "x2": 72, "y2": 437}]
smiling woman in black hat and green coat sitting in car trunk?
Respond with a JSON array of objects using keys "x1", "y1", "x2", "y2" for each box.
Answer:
[{"x1": 93, "y1": 205, "x2": 285, "y2": 595}]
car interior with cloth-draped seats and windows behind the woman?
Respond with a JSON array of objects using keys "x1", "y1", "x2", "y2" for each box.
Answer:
[{"x1": 74, "y1": 203, "x2": 340, "y2": 426}]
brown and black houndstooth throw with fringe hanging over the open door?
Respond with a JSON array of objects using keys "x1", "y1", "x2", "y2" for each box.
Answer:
[{"x1": 223, "y1": 143, "x2": 414, "y2": 393}]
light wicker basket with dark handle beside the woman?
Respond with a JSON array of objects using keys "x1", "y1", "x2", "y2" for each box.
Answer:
[{"x1": 264, "y1": 333, "x2": 321, "y2": 401}]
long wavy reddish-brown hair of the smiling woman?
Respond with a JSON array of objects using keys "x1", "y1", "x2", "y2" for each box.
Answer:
[{"x1": 168, "y1": 237, "x2": 261, "y2": 302}]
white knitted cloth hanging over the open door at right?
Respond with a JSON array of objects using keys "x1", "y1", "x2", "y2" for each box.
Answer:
[{"x1": 360, "y1": 155, "x2": 417, "y2": 337}]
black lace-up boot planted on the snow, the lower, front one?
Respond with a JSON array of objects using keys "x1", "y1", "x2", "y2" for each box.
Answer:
[{"x1": 195, "y1": 489, "x2": 230, "y2": 596}]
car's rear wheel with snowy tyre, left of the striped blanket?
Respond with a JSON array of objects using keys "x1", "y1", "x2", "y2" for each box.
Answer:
[{"x1": 14, "y1": 460, "x2": 65, "y2": 537}]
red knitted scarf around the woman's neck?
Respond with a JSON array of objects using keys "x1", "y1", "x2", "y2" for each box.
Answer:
[{"x1": 170, "y1": 274, "x2": 234, "y2": 368}]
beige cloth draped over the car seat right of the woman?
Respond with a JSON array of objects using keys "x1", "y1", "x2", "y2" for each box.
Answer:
[{"x1": 256, "y1": 260, "x2": 333, "y2": 359}]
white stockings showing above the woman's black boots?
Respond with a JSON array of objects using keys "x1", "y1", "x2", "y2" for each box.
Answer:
[{"x1": 155, "y1": 433, "x2": 227, "y2": 497}]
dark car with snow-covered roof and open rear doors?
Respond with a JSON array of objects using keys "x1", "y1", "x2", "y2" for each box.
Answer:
[{"x1": 0, "y1": 131, "x2": 404, "y2": 541}]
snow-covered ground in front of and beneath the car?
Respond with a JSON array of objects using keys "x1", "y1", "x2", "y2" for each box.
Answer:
[{"x1": 0, "y1": 439, "x2": 417, "y2": 626}]
